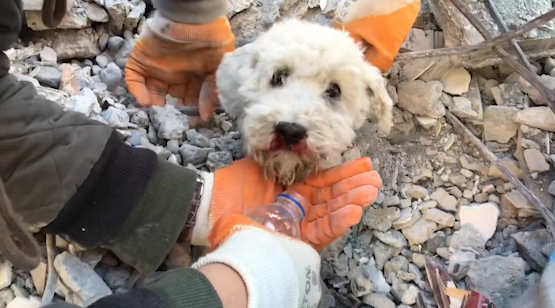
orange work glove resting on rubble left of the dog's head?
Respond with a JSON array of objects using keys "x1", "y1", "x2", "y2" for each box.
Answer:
[{"x1": 125, "y1": 14, "x2": 235, "y2": 120}]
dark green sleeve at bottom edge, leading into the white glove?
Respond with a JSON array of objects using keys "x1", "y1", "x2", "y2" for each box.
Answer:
[{"x1": 45, "y1": 269, "x2": 223, "y2": 308}]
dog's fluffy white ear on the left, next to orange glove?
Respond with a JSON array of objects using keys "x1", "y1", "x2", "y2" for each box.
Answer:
[{"x1": 216, "y1": 42, "x2": 258, "y2": 117}]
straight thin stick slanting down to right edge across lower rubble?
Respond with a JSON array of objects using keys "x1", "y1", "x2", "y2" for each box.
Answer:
[{"x1": 445, "y1": 111, "x2": 555, "y2": 239}]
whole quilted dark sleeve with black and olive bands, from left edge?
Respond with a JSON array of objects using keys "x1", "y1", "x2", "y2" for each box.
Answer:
[{"x1": 0, "y1": 71, "x2": 196, "y2": 273}]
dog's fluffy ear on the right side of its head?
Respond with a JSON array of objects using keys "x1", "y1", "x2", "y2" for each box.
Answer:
[{"x1": 363, "y1": 64, "x2": 393, "y2": 136}]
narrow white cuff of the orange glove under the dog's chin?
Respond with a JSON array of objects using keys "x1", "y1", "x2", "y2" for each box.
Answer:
[{"x1": 191, "y1": 171, "x2": 214, "y2": 247}]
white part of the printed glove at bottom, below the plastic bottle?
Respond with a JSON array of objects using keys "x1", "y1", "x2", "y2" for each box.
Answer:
[{"x1": 192, "y1": 227, "x2": 322, "y2": 308}]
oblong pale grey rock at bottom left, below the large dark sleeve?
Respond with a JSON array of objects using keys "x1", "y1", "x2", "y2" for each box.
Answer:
[{"x1": 54, "y1": 252, "x2": 112, "y2": 306}]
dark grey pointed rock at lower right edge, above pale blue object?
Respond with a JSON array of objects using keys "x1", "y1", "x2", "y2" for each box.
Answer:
[{"x1": 511, "y1": 229, "x2": 549, "y2": 273}]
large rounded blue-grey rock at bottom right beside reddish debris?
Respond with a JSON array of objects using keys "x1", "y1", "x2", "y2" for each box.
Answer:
[{"x1": 465, "y1": 256, "x2": 525, "y2": 308}]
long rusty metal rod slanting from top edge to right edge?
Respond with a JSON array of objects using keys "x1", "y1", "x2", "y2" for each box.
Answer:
[{"x1": 450, "y1": 0, "x2": 555, "y2": 113}]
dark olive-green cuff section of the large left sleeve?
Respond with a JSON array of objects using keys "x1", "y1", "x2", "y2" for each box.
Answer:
[{"x1": 104, "y1": 159, "x2": 197, "y2": 275}]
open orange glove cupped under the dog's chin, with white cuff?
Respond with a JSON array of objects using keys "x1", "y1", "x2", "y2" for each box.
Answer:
[{"x1": 192, "y1": 157, "x2": 382, "y2": 249}]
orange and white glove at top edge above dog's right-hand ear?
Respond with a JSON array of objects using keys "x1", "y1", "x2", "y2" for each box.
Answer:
[{"x1": 334, "y1": 0, "x2": 420, "y2": 73}]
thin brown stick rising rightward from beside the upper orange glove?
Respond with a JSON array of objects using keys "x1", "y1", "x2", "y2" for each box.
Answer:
[{"x1": 397, "y1": 9, "x2": 555, "y2": 61}]
